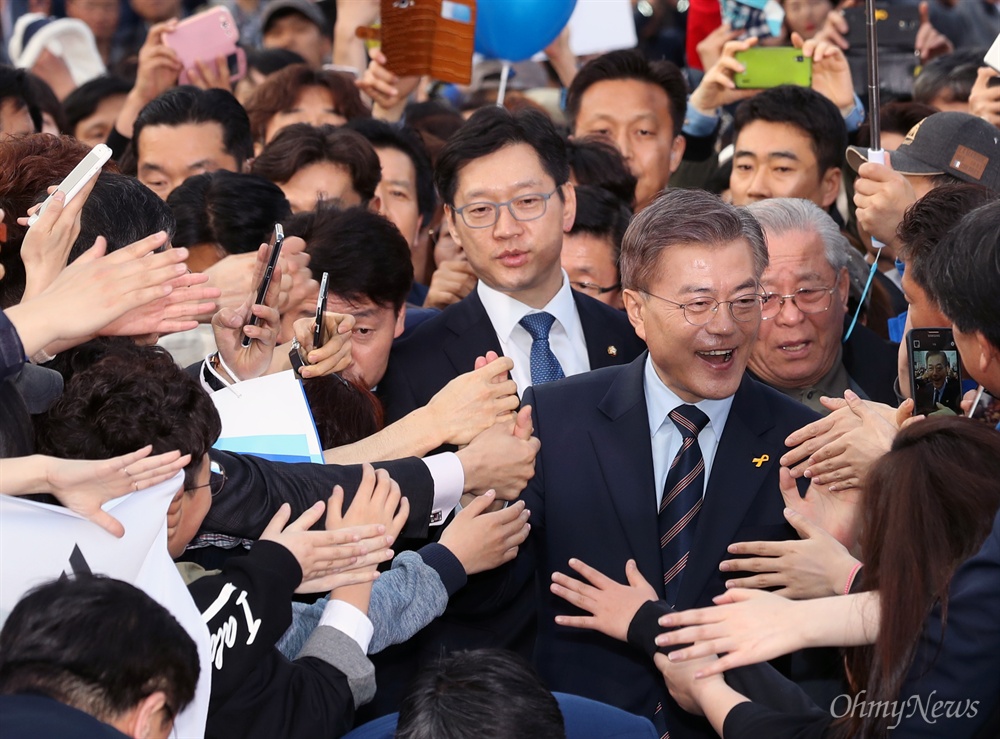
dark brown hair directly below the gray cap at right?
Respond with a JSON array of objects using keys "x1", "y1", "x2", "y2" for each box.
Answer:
[{"x1": 896, "y1": 182, "x2": 1000, "y2": 316}]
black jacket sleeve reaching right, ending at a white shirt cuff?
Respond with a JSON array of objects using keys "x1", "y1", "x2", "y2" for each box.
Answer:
[{"x1": 202, "y1": 449, "x2": 434, "y2": 539}]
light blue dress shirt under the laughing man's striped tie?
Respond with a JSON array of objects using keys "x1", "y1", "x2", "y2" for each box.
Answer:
[{"x1": 643, "y1": 356, "x2": 733, "y2": 510}]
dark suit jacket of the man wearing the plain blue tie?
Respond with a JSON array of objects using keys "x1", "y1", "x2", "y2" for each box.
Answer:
[{"x1": 378, "y1": 290, "x2": 645, "y2": 424}]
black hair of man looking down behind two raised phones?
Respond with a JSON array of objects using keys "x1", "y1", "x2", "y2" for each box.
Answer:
[{"x1": 285, "y1": 206, "x2": 413, "y2": 313}]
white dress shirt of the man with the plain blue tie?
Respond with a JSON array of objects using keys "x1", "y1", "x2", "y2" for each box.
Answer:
[{"x1": 476, "y1": 271, "x2": 590, "y2": 395}]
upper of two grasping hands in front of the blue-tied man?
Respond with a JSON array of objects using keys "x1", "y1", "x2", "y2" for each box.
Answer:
[{"x1": 426, "y1": 352, "x2": 520, "y2": 446}]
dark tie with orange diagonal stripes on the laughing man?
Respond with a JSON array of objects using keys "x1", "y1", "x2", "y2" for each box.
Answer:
[{"x1": 659, "y1": 405, "x2": 708, "y2": 605}]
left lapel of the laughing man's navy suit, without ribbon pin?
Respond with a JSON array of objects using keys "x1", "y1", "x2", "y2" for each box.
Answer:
[{"x1": 590, "y1": 352, "x2": 663, "y2": 596}]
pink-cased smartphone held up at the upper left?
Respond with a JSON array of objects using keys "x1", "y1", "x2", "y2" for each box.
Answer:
[{"x1": 163, "y1": 6, "x2": 247, "y2": 85}]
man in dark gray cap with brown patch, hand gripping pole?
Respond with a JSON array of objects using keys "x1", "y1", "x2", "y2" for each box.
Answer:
[{"x1": 847, "y1": 112, "x2": 1000, "y2": 246}]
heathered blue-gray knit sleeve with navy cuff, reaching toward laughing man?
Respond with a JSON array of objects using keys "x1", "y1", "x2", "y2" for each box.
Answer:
[{"x1": 368, "y1": 552, "x2": 448, "y2": 654}]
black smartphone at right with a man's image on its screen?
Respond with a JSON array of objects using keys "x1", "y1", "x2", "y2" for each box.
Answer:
[{"x1": 906, "y1": 328, "x2": 962, "y2": 415}]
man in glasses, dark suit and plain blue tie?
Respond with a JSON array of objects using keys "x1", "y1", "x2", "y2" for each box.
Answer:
[{"x1": 378, "y1": 107, "x2": 643, "y2": 422}]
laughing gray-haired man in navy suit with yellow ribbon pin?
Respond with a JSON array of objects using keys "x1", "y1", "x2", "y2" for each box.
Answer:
[{"x1": 500, "y1": 190, "x2": 817, "y2": 739}]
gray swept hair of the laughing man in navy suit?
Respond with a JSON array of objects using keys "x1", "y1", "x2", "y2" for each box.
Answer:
[{"x1": 620, "y1": 188, "x2": 768, "y2": 290}]
